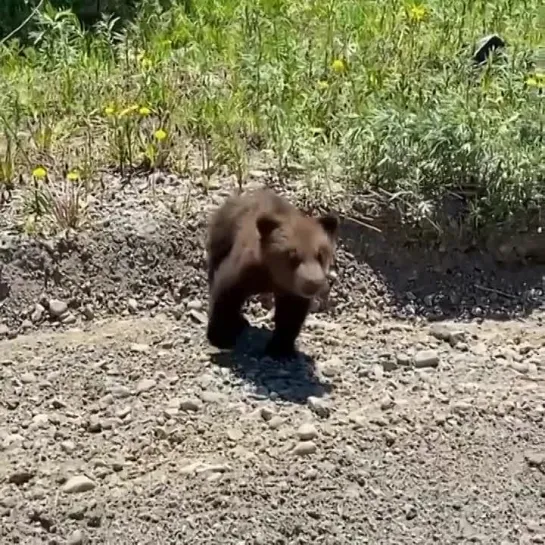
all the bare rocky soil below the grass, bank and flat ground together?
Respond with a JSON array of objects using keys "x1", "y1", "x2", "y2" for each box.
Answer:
[{"x1": 0, "y1": 172, "x2": 545, "y2": 545}]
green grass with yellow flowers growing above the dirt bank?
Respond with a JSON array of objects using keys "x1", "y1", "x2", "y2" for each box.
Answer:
[{"x1": 0, "y1": 0, "x2": 545, "y2": 236}]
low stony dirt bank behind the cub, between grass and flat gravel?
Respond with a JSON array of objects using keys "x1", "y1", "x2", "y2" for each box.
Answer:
[{"x1": 0, "y1": 176, "x2": 545, "y2": 336}]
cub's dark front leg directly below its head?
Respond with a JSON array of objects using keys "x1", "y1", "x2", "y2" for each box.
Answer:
[{"x1": 266, "y1": 294, "x2": 311, "y2": 358}]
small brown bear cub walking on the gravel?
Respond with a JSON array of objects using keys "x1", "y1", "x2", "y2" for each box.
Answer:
[{"x1": 207, "y1": 189, "x2": 339, "y2": 358}]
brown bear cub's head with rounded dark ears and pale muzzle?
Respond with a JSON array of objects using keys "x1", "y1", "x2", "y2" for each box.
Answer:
[{"x1": 257, "y1": 213, "x2": 339, "y2": 299}]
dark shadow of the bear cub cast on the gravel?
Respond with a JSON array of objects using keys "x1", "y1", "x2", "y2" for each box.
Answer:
[{"x1": 211, "y1": 326, "x2": 332, "y2": 404}]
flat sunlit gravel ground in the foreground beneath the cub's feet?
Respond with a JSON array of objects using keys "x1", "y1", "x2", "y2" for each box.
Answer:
[{"x1": 0, "y1": 315, "x2": 545, "y2": 545}]
